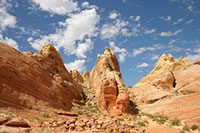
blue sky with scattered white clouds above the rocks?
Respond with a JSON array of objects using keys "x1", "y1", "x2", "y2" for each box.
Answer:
[{"x1": 0, "y1": 0, "x2": 200, "y2": 86}]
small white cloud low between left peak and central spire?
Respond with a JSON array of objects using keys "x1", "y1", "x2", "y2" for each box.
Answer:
[{"x1": 65, "y1": 59, "x2": 86, "y2": 72}]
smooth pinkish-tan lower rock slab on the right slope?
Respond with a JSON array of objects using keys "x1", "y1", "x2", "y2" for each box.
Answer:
[{"x1": 139, "y1": 93, "x2": 200, "y2": 125}]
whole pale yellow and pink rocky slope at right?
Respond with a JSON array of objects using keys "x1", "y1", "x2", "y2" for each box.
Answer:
[{"x1": 130, "y1": 54, "x2": 200, "y2": 124}]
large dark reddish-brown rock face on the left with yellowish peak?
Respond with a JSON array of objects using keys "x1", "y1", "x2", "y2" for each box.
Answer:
[{"x1": 0, "y1": 43, "x2": 82, "y2": 110}]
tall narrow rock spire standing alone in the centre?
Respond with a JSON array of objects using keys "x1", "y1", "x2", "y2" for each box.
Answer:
[{"x1": 90, "y1": 48, "x2": 129, "y2": 115}]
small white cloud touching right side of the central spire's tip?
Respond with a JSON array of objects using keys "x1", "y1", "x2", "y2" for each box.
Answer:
[{"x1": 109, "y1": 42, "x2": 128, "y2": 63}]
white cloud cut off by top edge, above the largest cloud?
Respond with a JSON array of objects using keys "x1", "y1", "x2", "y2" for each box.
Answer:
[{"x1": 32, "y1": 0, "x2": 78, "y2": 15}]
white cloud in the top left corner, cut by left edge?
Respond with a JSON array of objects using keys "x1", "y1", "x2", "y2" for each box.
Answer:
[{"x1": 0, "y1": 0, "x2": 17, "y2": 32}]
